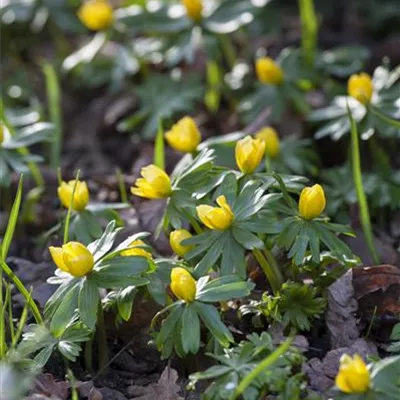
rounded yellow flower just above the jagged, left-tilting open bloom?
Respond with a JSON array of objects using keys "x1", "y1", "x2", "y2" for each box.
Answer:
[{"x1": 165, "y1": 117, "x2": 201, "y2": 153}]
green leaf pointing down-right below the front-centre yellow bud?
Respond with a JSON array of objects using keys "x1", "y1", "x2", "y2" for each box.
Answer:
[{"x1": 192, "y1": 301, "x2": 234, "y2": 347}]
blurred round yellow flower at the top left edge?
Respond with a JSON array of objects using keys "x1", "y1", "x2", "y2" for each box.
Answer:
[{"x1": 78, "y1": 0, "x2": 113, "y2": 31}]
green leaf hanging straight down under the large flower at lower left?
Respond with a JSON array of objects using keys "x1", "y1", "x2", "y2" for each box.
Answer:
[{"x1": 78, "y1": 277, "x2": 100, "y2": 330}]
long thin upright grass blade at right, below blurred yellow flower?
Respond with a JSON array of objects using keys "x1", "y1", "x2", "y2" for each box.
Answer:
[{"x1": 348, "y1": 110, "x2": 379, "y2": 264}]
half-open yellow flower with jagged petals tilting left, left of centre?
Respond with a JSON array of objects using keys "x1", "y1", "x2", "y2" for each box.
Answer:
[{"x1": 131, "y1": 164, "x2": 172, "y2": 199}]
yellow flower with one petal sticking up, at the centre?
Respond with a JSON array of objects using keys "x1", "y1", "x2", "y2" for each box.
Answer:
[{"x1": 196, "y1": 196, "x2": 234, "y2": 231}]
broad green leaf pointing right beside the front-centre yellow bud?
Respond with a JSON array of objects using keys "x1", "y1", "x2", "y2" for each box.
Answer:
[{"x1": 196, "y1": 276, "x2": 254, "y2": 303}]
